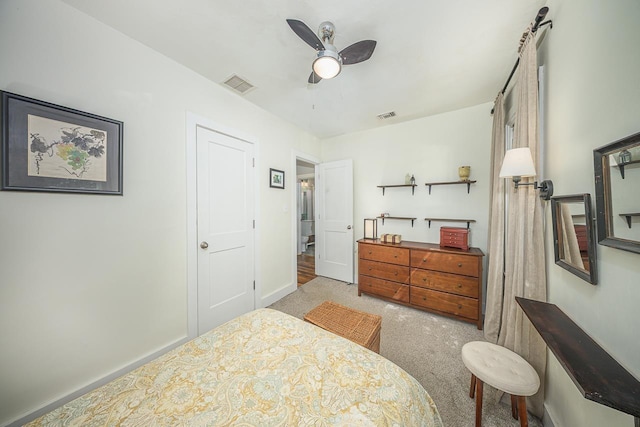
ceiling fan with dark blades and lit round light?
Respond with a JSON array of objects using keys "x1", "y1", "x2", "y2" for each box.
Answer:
[{"x1": 287, "y1": 19, "x2": 376, "y2": 84}]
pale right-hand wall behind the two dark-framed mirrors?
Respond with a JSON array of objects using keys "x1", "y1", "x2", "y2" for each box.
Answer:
[{"x1": 540, "y1": 0, "x2": 640, "y2": 427}]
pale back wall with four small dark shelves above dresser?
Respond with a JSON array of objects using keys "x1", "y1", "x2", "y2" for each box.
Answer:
[{"x1": 322, "y1": 104, "x2": 492, "y2": 280}]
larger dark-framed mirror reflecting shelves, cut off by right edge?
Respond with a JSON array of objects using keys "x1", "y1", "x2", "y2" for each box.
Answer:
[{"x1": 593, "y1": 133, "x2": 640, "y2": 253}]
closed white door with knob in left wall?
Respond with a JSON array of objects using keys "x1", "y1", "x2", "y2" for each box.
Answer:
[{"x1": 196, "y1": 127, "x2": 254, "y2": 335}]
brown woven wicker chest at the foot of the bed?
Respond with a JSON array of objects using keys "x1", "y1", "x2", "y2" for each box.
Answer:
[{"x1": 304, "y1": 301, "x2": 382, "y2": 353}]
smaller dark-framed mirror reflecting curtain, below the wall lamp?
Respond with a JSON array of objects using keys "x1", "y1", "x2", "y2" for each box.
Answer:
[{"x1": 551, "y1": 194, "x2": 598, "y2": 285}]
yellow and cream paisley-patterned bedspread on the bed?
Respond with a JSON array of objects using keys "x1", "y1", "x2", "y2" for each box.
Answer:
[{"x1": 27, "y1": 309, "x2": 442, "y2": 427}]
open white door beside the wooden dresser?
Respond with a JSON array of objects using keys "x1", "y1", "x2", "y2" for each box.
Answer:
[{"x1": 316, "y1": 159, "x2": 353, "y2": 283}]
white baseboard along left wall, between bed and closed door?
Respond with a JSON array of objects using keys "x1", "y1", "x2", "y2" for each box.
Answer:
[{"x1": 6, "y1": 337, "x2": 189, "y2": 427}]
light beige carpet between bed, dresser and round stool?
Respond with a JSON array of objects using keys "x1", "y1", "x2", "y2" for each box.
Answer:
[{"x1": 270, "y1": 277, "x2": 542, "y2": 427}]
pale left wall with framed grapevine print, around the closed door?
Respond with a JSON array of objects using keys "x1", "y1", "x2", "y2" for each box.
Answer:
[{"x1": 0, "y1": 0, "x2": 319, "y2": 425}]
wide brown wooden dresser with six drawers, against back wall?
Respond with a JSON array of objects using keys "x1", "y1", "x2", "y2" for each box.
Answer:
[{"x1": 358, "y1": 239, "x2": 484, "y2": 329}]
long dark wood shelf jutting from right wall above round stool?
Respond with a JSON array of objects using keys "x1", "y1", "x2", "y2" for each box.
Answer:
[{"x1": 516, "y1": 297, "x2": 640, "y2": 427}]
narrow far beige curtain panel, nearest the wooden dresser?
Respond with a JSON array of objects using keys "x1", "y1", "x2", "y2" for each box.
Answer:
[{"x1": 484, "y1": 92, "x2": 505, "y2": 343}]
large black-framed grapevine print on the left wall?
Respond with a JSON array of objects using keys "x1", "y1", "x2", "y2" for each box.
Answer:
[{"x1": 0, "y1": 91, "x2": 124, "y2": 196}]
